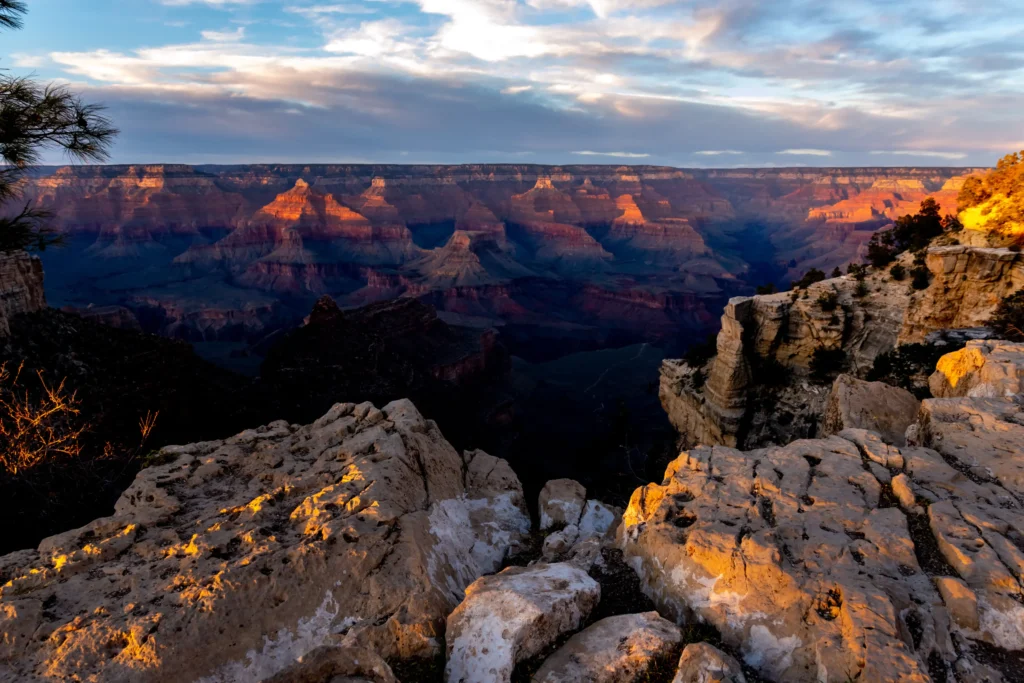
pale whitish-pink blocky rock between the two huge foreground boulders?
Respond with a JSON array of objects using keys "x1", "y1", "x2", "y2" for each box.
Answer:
[{"x1": 444, "y1": 563, "x2": 601, "y2": 683}]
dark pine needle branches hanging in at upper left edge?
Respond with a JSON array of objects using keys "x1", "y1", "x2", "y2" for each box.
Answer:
[{"x1": 0, "y1": 0, "x2": 118, "y2": 252}]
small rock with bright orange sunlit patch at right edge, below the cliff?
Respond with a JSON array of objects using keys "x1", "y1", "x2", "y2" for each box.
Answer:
[{"x1": 928, "y1": 340, "x2": 1024, "y2": 398}]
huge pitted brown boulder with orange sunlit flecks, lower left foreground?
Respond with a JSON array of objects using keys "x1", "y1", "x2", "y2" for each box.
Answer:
[{"x1": 0, "y1": 401, "x2": 529, "y2": 683}]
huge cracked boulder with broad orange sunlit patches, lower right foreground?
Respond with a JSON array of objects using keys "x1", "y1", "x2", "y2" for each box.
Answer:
[{"x1": 621, "y1": 430, "x2": 1024, "y2": 683}]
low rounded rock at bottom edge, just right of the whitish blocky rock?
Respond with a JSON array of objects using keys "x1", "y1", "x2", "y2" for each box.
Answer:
[{"x1": 531, "y1": 612, "x2": 683, "y2": 683}]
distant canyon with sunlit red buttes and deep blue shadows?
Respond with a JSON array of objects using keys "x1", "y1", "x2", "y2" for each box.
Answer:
[{"x1": 24, "y1": 165, "x2": 977, "y2": 360}]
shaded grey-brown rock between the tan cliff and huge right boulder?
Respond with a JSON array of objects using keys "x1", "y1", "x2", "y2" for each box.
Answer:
[{"x1": 822, "y1": 375, "x2": 921, "y2": 445}]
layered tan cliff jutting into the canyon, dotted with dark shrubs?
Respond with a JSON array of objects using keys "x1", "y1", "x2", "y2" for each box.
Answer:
[{"x1": 659, "y1": 247, "x2": 1024, "y2": 447}]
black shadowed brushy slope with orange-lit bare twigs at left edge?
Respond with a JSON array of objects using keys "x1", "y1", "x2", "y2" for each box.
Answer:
[{"x1": 0, "y1": 309, "x2": 266, "y2": 553}]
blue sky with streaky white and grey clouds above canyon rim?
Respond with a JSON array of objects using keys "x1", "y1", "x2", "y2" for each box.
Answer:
[{"x1": 6, "y1": 0, "x2": 1024, "y2": 167}]
